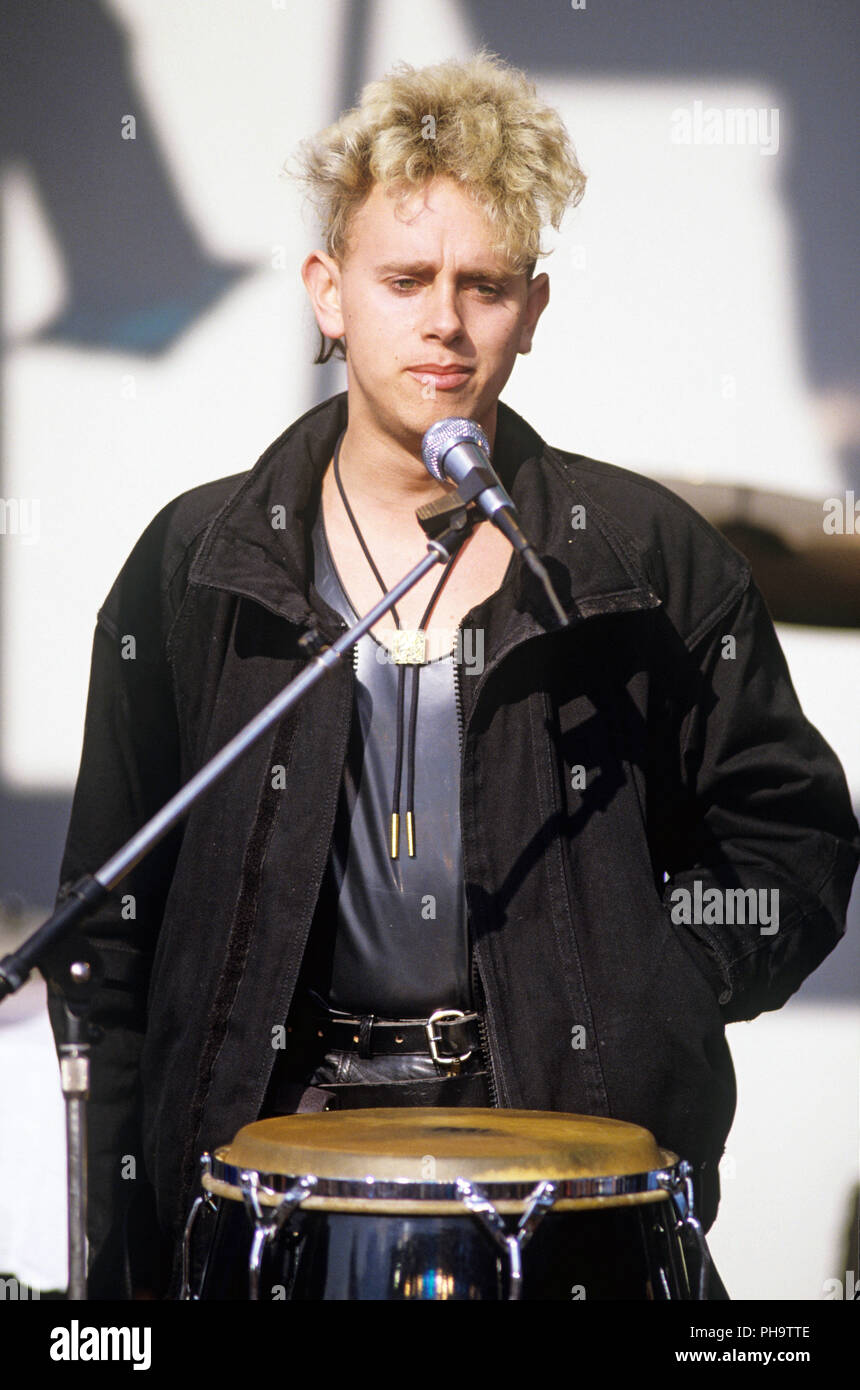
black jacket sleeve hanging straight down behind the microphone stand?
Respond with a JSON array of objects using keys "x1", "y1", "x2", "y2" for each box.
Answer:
[{"x1": 46, "y1": 527, "x2": 181, "y2": 1298}]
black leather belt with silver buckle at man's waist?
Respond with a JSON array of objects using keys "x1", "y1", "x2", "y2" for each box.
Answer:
[{"x1": 288, "y1": 1009, "x2": 481, "y2": 1070}]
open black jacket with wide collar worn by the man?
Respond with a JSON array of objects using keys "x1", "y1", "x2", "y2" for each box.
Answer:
[{"x1": 51, "y1": 395, "x2": 860, "y2": 1289}]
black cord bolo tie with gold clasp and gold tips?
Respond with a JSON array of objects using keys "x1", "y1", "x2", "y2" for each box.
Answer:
[{"x1": 333, "y1": 430, "x2": 456, "y2": 859}]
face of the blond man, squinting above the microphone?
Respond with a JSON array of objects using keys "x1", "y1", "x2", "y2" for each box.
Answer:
[{"x1": 306, "y1": 178, "x2": 549, "y2": 452}]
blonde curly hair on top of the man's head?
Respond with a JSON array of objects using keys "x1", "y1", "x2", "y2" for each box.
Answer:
[{"x1": 288, "y1": 49, "x2": 585, "y2": 361}]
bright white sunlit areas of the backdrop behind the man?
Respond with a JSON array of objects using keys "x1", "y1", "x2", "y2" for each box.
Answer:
[{"x1": 0, "y1": 0, "x2": 860, "y2": 1298}]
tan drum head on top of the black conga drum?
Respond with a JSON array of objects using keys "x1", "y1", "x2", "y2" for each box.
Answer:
[{"x1": 206, "y1": 1108, "x2": 678, "y2": 1205}]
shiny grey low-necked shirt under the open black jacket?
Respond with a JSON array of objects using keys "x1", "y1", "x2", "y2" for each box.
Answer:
[{"x1": 297, "y1": 494, "x2": 471, "y2": 1019}]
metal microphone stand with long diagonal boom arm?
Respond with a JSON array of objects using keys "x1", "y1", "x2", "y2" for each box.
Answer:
[{"x1": 0, "y1": 491, "x2": 483, "y2": 1301}]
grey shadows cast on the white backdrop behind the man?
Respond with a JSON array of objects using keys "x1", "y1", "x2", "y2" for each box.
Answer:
[{"x1": 0, "y1": 0, "x2": 860, "y2": 999}]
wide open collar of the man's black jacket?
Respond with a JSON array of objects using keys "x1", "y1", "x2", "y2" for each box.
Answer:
[{"x1": 189, "y1": 392, "x2": 660, "y2": 632}]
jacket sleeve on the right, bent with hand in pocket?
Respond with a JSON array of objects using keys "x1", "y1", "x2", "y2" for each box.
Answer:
[{"x1": 664, "y1": 569, "x2": 860, "y2": 1022}]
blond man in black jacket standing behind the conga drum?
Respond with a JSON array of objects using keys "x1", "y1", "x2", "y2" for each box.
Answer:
[{"x1": 53, "y1": 56, "x2": 859, "y2": 1297}]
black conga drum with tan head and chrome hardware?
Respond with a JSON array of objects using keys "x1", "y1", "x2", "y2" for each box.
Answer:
[{"x1": 181, "y1": 1108, "x2": 704, "y2": 1301}]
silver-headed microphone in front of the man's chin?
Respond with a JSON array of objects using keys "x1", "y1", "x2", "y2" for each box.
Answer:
[{"x1": 421, "y1": 417, "x2": 567, "y2": 627}]
